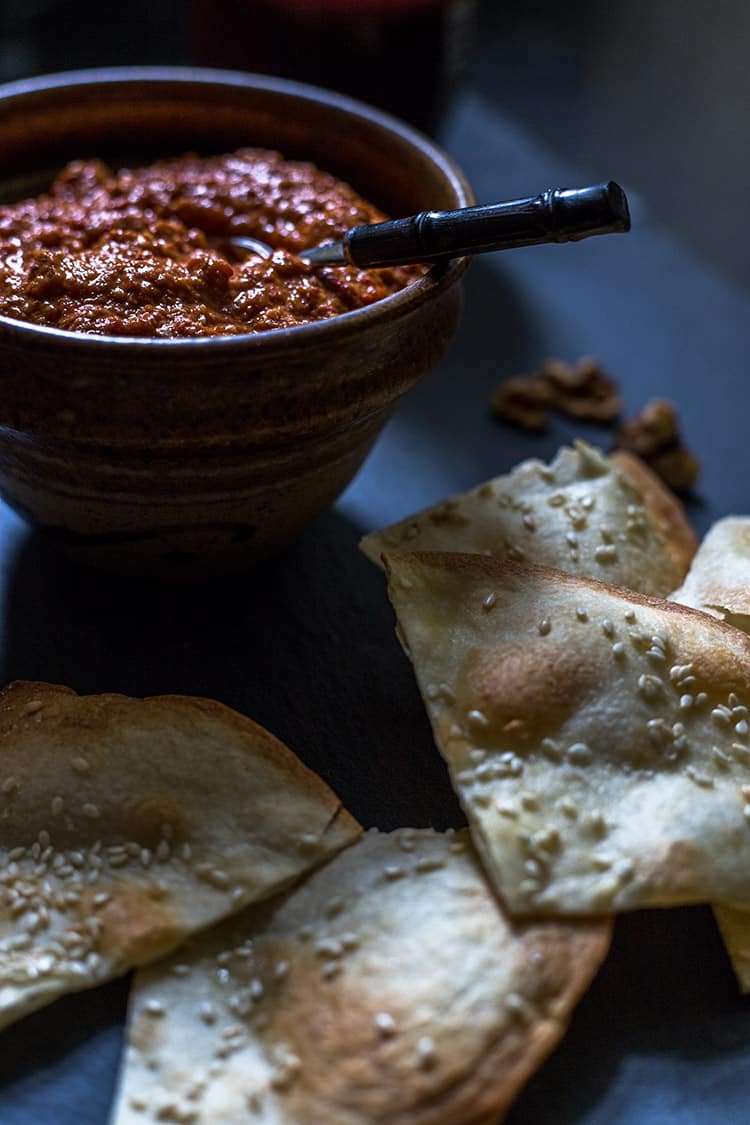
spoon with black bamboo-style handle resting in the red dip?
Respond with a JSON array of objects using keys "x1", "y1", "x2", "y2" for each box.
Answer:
[{"x1": 216, "y1": 180, "x2": 630, "y2": 269}]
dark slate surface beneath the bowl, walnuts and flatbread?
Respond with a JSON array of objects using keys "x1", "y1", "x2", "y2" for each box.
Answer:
[{"x1": 0, "y1": 98, "x2": 750, "y2": 1125}]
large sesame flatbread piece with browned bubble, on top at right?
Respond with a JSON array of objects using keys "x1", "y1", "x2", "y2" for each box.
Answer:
[{"x1": 386, "y1": 554, "x2": 750, "y2": 915}]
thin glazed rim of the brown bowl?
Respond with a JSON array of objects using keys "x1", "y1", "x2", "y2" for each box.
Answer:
[{"x1": 0, "y1": 65, "x2": 475, "y2": 356}]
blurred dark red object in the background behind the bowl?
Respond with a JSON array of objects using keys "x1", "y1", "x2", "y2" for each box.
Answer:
[{"x1": 190, "y1": 0, "x2": 477, "y2": 133}]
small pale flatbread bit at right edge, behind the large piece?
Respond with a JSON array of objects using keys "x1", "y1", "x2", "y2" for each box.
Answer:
[{"x1": 669, "y1": 516, "x2": 750, "y2": 632}]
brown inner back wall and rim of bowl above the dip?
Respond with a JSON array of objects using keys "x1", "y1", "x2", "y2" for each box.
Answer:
[{"x1": 0, "y1": 68, "x2": 472, "y2": 216}]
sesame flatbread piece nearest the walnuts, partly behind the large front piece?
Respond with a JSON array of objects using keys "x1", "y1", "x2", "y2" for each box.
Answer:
[{"x1": 361, "y1": 441, "x2": 696, "y2": 596}]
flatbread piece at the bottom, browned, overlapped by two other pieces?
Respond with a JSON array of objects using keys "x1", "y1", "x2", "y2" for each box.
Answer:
[{"x1": 112, "y1": 829, "x2": 609, "y2": 1125}]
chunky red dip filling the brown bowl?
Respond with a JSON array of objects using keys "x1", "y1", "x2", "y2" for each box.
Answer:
[{"x1": 0, "y1": 149, "x2": 423, "y2": 338}]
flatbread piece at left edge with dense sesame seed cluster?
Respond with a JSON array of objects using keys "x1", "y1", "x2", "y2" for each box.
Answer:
[{"x1": 0, "y1": 683, "x2": 359, "y2": 1027}]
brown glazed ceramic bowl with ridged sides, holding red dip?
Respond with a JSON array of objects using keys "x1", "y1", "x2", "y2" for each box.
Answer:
[{"x1": 0, "y1": 68, "x2": 473, "y2": 579}]
